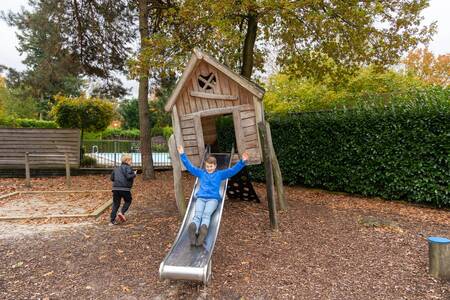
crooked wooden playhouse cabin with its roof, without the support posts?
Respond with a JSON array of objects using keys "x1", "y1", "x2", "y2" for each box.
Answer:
[{"x1": 165, "y1": 50, "x2": 264, "y2": 165}]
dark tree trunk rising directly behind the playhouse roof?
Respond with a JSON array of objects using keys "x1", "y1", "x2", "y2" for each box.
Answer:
[{"x1": 241, "y1": 13, "x2": 258, "y2": 79}]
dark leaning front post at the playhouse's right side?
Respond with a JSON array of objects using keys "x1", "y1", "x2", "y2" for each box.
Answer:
[{"x1": 258, "y1": 122, "x2": 278, "y2": 230}]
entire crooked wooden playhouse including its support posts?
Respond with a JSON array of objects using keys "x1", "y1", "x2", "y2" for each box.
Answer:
[{"x1": 165, "y1": 49, "x2": 286, "y2": 228}]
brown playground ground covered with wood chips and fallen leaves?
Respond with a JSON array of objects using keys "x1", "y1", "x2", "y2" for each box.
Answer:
[{"x1": 0, "y1": 171, "x2": 450, "y2": 299}]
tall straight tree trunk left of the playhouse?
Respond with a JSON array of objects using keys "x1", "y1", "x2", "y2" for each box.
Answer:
[{"x1": 138, "y1": 0, "x2": 155, "y2": 180}]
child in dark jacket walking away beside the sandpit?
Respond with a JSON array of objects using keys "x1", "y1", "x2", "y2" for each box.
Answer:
[{"x1": 110, "y1": 154, "x2": 136, "y2": 225}]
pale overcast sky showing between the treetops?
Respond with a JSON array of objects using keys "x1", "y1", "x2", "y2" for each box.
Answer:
[{"x1": 0, "y1": 0, "x2": 450, "y2": 96}]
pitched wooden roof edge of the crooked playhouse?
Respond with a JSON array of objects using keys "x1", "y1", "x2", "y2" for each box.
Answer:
[{"x1": 165, "y1": 49, "x2": 265, "y2": 111}]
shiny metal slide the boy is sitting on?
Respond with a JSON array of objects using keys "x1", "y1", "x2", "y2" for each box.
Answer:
[{"x1": 159, "y1": 147, "x2": 233, "y2": 284}]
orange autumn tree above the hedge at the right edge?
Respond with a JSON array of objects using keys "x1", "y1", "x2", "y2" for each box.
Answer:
[{"x1": 403, "y1": 48, "x2": 450, "y2": 86}]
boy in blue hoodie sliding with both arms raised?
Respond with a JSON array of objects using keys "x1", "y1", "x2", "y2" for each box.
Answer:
[{"x1": 178, "y1": 146, "x2": 248, "y2": 246}]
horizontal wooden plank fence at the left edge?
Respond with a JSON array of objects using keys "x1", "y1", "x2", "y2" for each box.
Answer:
[{"x1": 0, "y1": 128, "x2": 80, "y2": 169}]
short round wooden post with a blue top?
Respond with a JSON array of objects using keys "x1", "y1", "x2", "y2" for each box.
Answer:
[{"x1": 428, "y1": 237, "x2": 450, "y2": 281}]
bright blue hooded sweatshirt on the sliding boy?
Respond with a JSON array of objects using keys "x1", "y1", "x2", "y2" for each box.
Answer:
[{"x1": 181, "y1": 153, "x2": 245, "y2": 201}]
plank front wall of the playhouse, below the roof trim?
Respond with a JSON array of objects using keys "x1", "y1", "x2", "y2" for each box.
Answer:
[{"x1": 175, "y1": 62, "x2": 261, "y2": 165}]
